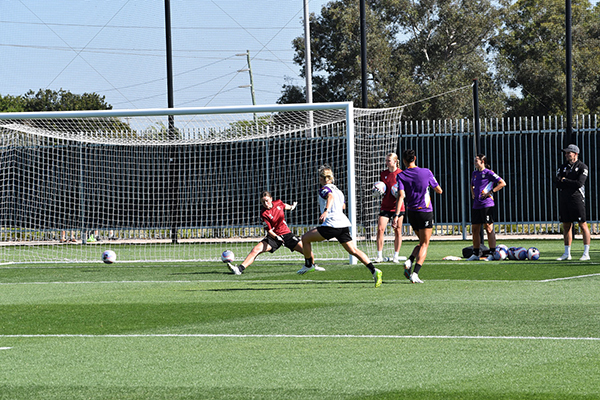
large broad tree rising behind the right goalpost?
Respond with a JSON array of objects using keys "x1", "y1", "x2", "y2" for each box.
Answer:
[{"x1": 280, "y1": 0, "x2": 504, "y2": 119}]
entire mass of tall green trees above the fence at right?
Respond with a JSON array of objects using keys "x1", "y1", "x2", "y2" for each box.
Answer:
[{"x1": 279, "y1": 0, "x2": 600, "y2": 119}]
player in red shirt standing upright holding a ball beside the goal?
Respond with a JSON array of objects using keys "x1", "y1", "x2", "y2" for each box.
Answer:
[{"x1": 373, "y1": 153, "x2": 406, "y2": 263}]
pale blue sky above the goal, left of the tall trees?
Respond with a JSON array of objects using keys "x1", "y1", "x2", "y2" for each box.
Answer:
[{"x1": 0, "y1": 0, "x2": 328, "y2": 109}]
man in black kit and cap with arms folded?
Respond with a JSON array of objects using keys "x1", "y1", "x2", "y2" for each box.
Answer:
[{"x1": 554, "y1": 144, "x2": 591, "y2": 261}]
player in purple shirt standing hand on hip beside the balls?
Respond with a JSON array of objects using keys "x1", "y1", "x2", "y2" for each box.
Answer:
[{"x1": 467, "y1": 154, "x2": 506, "y2": 261}]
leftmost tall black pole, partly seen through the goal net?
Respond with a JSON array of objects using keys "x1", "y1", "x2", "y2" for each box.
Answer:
[{"x1": 165, "y1": 0, "x2": 179, "y2": 243}]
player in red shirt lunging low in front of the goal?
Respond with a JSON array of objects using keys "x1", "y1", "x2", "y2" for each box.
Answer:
[{"x1": 227, "y1": 191, "x2": 325, "y2": 275}]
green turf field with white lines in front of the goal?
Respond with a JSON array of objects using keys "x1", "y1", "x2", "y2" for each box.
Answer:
[{"x1": 0, "y1": 240, "x2": 600, "y2": 400}]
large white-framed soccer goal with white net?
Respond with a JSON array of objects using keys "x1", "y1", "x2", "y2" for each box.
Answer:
[{"x1": 0, "y1": 103, "x2": 402, "y2": 263}]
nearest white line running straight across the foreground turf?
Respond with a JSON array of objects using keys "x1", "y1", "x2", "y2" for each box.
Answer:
[{"x1": 0, "y1": 333, "x2": 600, "y2": 340}]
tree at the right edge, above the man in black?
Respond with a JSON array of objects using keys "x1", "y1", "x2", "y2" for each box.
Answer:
[{"x1": 492, "y1": 0, "x2": 600, "y2": 116}]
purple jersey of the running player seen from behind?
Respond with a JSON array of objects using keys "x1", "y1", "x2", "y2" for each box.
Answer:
[{"x1": 396, "y1": 167, "x2": 439, "y2": 212}]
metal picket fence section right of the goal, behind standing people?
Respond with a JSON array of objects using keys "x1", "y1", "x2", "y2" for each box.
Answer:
[{"x1": 398, "y1": 115, "x2": 600, "y2": 237}]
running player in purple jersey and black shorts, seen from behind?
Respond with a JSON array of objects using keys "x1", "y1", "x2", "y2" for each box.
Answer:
[{"x1": 392, "y1": 150, "x2": 442, "y2": 283}]
